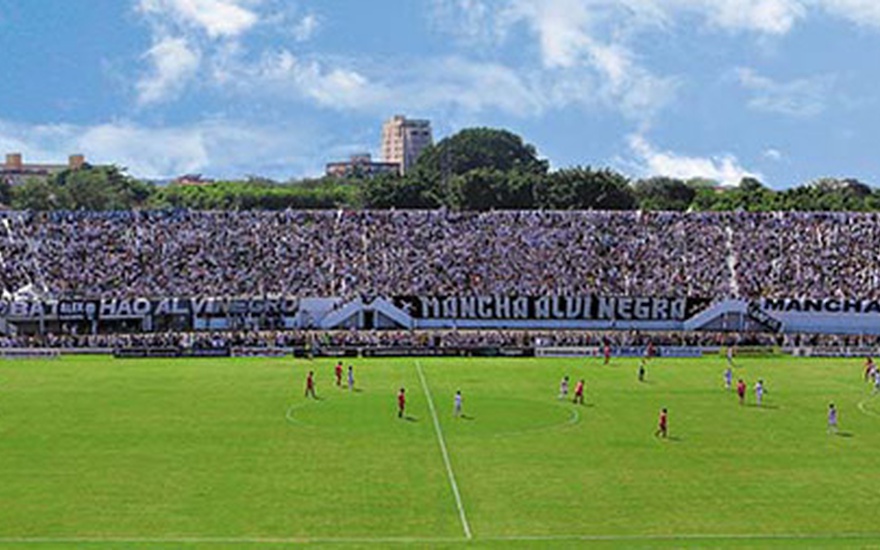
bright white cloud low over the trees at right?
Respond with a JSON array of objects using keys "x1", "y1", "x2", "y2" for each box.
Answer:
[{"x1": 629, "y1": 135, "x2": 761, "y2": 185}]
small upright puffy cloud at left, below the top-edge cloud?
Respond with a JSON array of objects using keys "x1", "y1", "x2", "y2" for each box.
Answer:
[{"x1": 135, "y1": 37, "x2": 201, "y2": 105}]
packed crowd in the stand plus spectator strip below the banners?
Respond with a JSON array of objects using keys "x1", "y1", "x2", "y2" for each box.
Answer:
[{"x1": 0, "y1": 210, "x2": 880, "y2": 348}]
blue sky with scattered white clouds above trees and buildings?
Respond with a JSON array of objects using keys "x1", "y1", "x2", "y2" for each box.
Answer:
[{"x1": 0, "y1": 0, "x2": 880, "y2": 188}]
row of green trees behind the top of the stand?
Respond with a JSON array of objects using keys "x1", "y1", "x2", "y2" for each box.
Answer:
[{"x1": 6, "y1": 128, "x2": 880, "y2": 212}]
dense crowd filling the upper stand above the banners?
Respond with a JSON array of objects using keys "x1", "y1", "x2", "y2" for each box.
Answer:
[{"x1": 0, "y1": 210, "x2": 880, "y2": 298}]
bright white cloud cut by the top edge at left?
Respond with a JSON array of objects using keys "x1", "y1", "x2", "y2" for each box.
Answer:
[{"x1": 138, "y1": 0, "x2": 259, "y2": 38}]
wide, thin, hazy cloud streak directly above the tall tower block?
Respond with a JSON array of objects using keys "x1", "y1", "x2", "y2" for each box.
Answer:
[{"x1": 237, "y1": 50, "x2": 576, "y2": 116}]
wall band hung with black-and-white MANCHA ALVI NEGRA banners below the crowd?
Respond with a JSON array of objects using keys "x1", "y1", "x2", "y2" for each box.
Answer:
[{"x1": 0, "y1": 295, "x2": 880, "y2": 335}]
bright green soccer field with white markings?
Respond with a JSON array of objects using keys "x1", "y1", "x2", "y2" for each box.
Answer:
[{"x1": 0, "y1": 357, "x2": 880, "y2": 549}]
